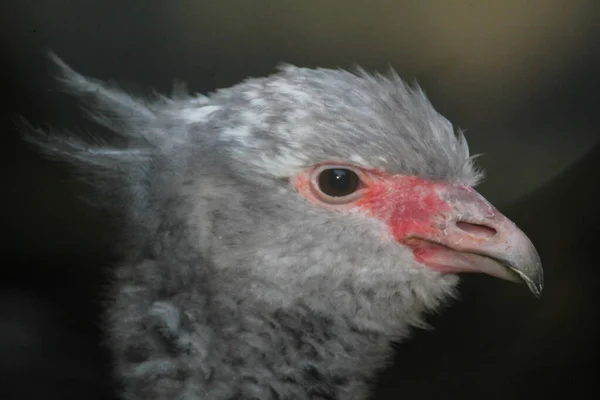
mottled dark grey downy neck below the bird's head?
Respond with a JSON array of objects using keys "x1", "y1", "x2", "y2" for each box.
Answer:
[{"x1": 106, "y1": 257, "x2": 426, "y2": 400}]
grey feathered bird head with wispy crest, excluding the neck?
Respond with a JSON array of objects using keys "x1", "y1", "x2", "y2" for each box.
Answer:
[{"x1": 27, "y1": 58, "x2": 543, "y2": 336}]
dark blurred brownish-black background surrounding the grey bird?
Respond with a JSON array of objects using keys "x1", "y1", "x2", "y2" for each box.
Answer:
[{"x1": 0, "y1": 0, "x2": 600, "y2": 400}]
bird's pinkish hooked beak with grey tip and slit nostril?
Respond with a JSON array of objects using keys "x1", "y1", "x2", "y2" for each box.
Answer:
[{"x1": 390, "y1": 182, "x2": 544, "y2": 297}]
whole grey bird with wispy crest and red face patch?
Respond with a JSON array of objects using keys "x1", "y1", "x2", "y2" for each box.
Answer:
[{"x1": 24, "y1": 53, "x2": 543, "y2": 400}]
